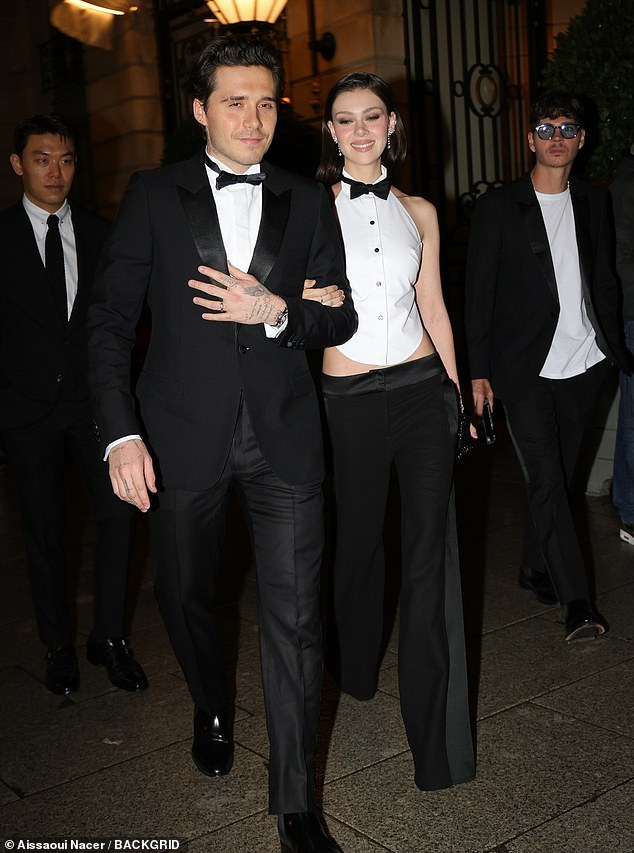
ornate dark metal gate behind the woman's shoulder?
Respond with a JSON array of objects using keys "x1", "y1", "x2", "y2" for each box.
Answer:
[{"x1": 404, "y1": 0, "x2": 546, "y2": 286}]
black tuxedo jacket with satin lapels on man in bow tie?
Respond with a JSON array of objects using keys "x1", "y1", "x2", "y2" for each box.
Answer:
[{"x1": 89, "y1": 152, "x2": 356, "y2": 490}]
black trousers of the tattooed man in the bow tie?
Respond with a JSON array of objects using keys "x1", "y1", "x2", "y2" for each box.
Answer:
[{"x1": 151, "y1": 404, "x2": 324, "y2": 814}]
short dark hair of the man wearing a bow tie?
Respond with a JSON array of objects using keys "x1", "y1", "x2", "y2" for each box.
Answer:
[{"x1": 189, "y1": 36, "x2": 284, "y2": 106}]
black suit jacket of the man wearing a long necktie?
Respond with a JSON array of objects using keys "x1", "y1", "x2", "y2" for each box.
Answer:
[{"x1": 0, "y1": 201, "x2": 109, "y2": 429}]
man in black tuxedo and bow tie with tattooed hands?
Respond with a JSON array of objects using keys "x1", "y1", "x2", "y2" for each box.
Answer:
[{"x1": 90, "y1": 37, "x2": 356, "y2": 851}]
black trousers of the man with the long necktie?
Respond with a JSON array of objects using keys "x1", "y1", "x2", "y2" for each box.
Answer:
[{"x1": 2, "y1": 402, "x2": 134, "y2": 648}]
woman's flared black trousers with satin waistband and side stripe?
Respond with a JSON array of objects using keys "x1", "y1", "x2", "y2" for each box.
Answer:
[{"x1": 322, "y1": 355, "x2": 473, "y2": 789}]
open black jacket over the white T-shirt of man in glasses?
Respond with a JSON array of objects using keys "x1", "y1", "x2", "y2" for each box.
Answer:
[{"x1": 465, "y1": 174, "x2": 630, "y2": 402}]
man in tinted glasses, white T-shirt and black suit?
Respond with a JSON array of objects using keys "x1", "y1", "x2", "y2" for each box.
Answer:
[{"x1": 466, "y1": 92, "x2": 629, "y2": 641}]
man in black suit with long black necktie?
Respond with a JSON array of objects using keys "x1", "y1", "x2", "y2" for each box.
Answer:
[{"x1": 0, "y1": 114, "x2": 147, "y2": 694}]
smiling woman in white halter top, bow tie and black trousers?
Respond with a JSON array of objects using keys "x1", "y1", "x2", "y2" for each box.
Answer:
[{"x1": 304, "y1": 73, "x2": 474, "y2": 789}]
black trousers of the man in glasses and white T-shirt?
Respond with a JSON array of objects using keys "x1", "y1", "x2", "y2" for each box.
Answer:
[{"x1": 504, "y1": 361, "x2": 610, "y2": 604}]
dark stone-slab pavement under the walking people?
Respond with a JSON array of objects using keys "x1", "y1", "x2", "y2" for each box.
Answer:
[{"x1": 0, "y1": 425, "x2": 634, "y2": 853}]
